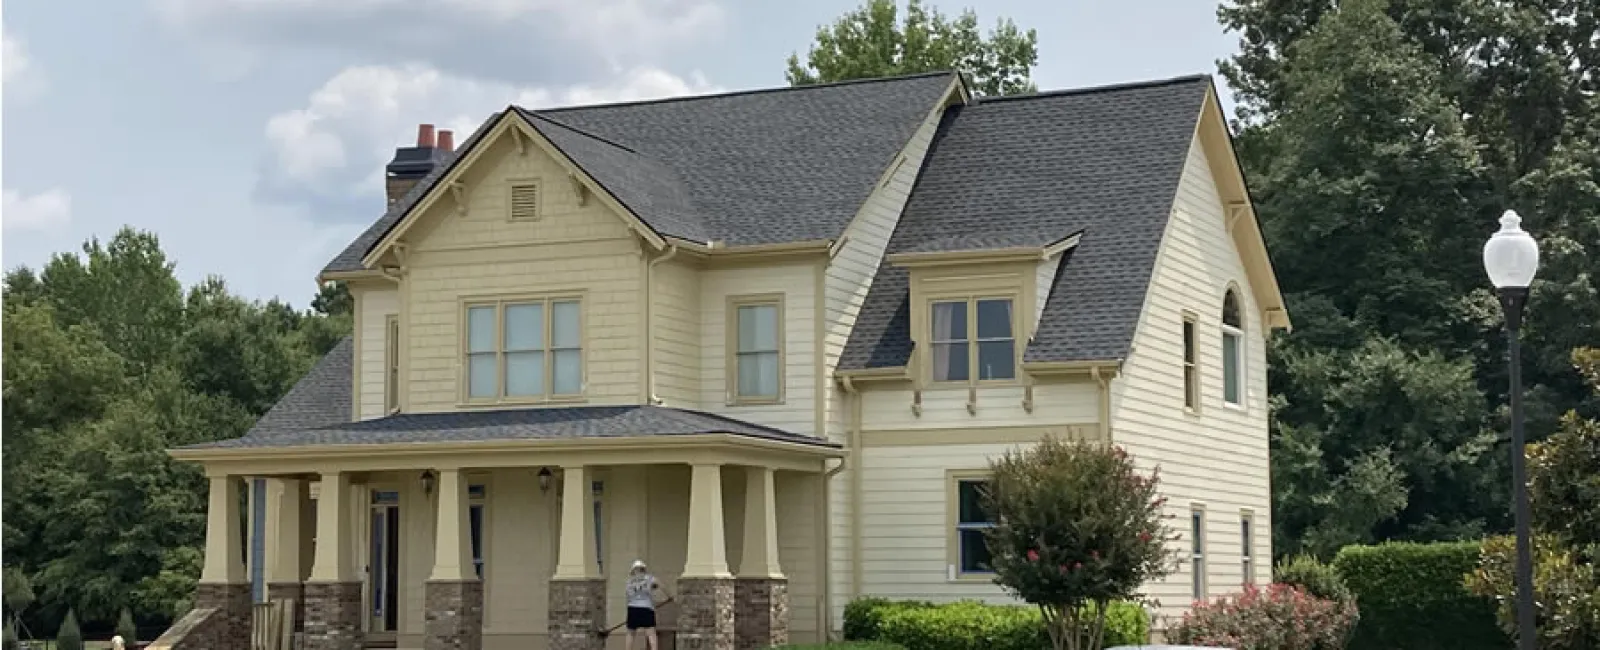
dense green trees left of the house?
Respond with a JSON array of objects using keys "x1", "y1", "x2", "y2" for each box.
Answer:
[{"x1": 0, "y1": 229, "x2": 349, "y2": 629}]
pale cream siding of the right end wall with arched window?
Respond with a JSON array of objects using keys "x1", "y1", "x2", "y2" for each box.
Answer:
[{"x1": 1112, "y1": 133, "x2": 1272, "y2": 624}]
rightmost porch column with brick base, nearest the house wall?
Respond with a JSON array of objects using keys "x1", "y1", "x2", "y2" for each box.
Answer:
[{"x1": 733, "y1": 467, "x2": 789, "y2": 650}]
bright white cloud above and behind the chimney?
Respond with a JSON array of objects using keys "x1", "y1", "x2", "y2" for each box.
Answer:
[{"x1": 260, "y1": 63, "x2": 717, "y2": 205}]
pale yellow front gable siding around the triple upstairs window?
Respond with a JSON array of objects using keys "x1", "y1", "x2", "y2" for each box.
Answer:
[{"x1": 405, "y1": 130, "x2": 643, "y2": 411}]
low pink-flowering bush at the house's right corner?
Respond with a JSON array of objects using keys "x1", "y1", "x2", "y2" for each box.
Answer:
[{"x1": 1166, "y1": 583, "x2": 1357, "y2": 650}]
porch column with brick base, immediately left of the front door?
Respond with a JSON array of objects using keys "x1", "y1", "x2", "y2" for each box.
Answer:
[{"x1": 304, "y1": 472, "x2": 362, "y2": 650}]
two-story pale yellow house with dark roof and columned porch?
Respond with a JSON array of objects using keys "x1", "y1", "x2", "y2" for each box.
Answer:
[{"x1": 159, "y1": 74, "x2": 1288, "y2": 650}]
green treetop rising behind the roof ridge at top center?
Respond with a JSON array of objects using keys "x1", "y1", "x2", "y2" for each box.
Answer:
[{"x1": 784, "y1": 0, "x2": 1038, "y2": 94}]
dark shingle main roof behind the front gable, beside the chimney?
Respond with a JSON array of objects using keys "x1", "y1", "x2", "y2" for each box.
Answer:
[{"x1": 323, "y1": 72, "x2": 954, "y2": 272}]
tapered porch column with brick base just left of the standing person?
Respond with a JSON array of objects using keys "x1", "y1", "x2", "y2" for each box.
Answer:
[{"x1": 547, "y1": 466, "x2": 605, "y2": 650}]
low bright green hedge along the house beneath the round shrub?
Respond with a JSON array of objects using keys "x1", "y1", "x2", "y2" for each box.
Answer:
[{"x1": 845, "y1": 599, "x2": 1150, "y2": 650}]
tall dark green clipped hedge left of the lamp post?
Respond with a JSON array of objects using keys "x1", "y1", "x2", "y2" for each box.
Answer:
[{"x1": 1333, "y1": 541, "x2": 1510, "y2": 650}]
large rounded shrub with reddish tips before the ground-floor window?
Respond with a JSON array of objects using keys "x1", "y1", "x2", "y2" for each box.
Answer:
[{"x1": 979, "y1": 437, "x2": 1171, "y2": 650}]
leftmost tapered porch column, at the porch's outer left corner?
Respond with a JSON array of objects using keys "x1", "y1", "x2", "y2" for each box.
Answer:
[{"x1": 195, "y1": 475, "x2": 251, "y2": 650}]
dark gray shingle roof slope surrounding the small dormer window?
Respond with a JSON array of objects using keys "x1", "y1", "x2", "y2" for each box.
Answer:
[{"x1": 838, "y1": 75, "x2": 1211, "y2": 370}]
